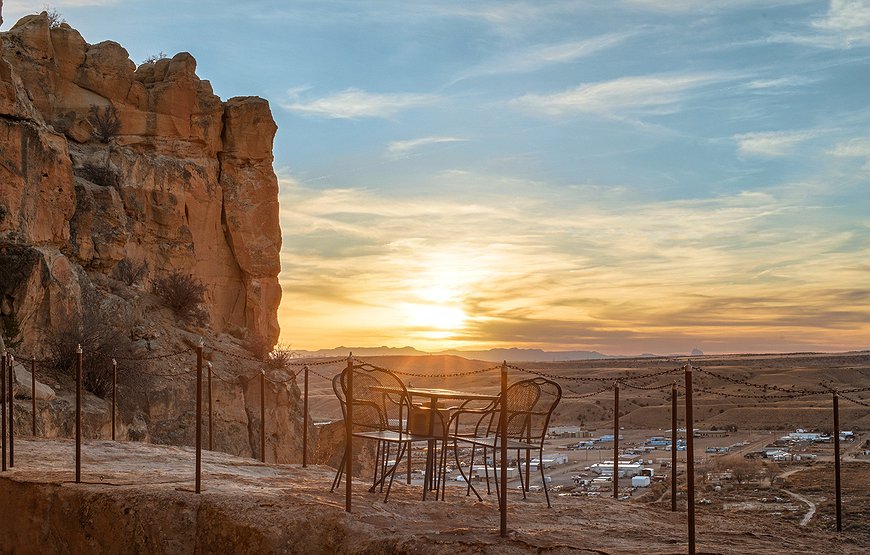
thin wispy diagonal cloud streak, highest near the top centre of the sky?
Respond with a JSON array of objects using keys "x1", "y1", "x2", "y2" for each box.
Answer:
[{"x1": 453, "y1": 31, "x2": 637, "y2": 82}]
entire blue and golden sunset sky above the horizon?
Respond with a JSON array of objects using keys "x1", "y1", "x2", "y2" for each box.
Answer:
[{"x1": 3, "y1": 0, "x2": 870, "y2": 354}]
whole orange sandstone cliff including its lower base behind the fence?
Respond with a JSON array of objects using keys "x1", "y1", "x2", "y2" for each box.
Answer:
[{"x1": 0, "y1": 10, "x2": 302, "y2": 462}]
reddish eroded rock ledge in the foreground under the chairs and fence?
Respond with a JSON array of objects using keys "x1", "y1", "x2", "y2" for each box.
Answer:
[{"x1": 0, "y1": 440, "x2": 866, "y2": 555}]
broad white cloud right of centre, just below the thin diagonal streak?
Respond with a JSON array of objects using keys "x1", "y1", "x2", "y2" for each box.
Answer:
[{"x1": 512, "y1": 73, "x2": 734, "y2": 116}]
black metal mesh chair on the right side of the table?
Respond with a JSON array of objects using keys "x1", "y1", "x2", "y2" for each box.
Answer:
[{"x1": 450, "y1": 378, "x2": 562, "y2": 507}]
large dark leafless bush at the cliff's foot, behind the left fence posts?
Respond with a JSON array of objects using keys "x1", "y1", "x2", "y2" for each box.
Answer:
[{"x1": 47, "y1": 309, "x2": 132, "y2": 398}]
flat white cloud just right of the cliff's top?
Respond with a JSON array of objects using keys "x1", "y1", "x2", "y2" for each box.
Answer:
[{"x1": 279, "y1": 88, "x2": 439, "y2": 119}]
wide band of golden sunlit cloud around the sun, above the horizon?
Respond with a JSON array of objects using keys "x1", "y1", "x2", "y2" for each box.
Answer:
[{"x1": 282, "y1": 172, "x2": 870, "y2": 354}]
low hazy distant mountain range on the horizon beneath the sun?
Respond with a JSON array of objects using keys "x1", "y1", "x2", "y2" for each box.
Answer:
[{"x1": 294, "y1": 347, "x2": 616, "y2": 362}]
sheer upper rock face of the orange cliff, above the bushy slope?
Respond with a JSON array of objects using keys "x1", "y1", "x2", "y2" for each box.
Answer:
[{"x1": 0, "y1": 13, "x2": 281, "y2": 348}]
